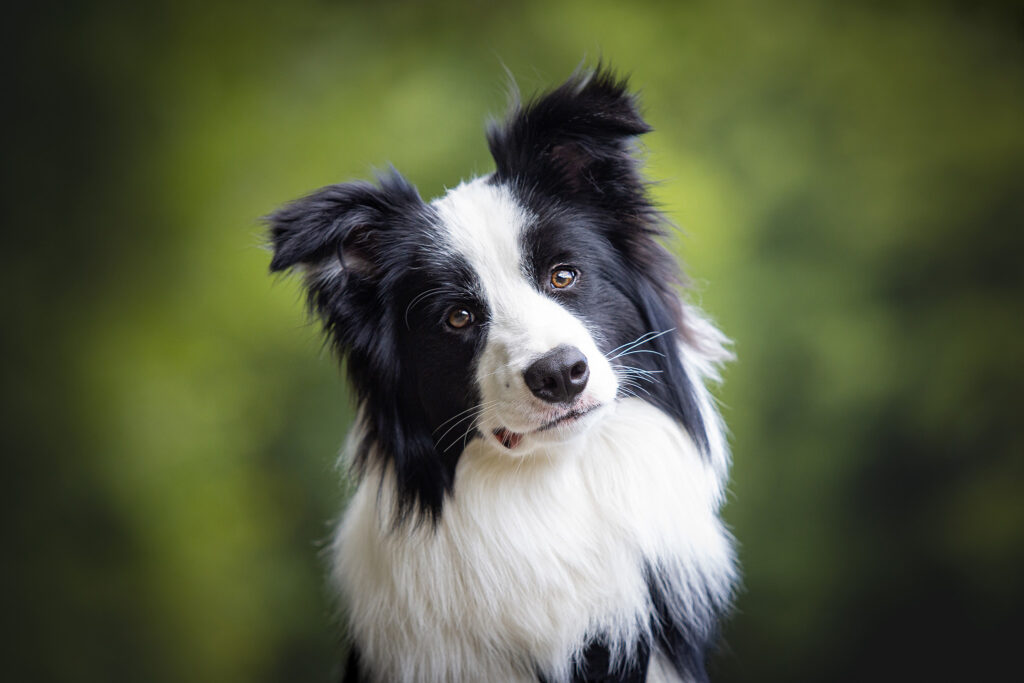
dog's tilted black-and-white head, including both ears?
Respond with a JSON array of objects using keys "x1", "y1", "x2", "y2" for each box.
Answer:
[{"x1": 269, "y1": 70, "x2": 706, "y2": 515}]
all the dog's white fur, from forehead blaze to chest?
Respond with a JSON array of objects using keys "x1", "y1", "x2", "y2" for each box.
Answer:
[{"x1": 334, "y1": 181, "x2": 734, "y2": 683}]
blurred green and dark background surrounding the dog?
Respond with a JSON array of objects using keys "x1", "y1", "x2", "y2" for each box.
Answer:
[{"x1": 0, "y1": 0, "x2": 1024, "y2": 683}]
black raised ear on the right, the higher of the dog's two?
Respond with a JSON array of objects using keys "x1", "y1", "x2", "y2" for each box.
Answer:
[{"x1": 487, "y1": 65, "x2": 651, "y2": 203}]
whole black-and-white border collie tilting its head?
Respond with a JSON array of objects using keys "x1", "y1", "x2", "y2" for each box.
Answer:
[{"x1": 268, "y1": 66, "x2": 736, "y2": 683}]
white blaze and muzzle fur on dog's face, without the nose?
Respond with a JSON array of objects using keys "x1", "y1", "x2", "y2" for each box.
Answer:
[{"x1": 433, "y1": 179, "x2": 617, "y2": 454}]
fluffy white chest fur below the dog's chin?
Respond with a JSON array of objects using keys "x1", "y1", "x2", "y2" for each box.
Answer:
[{"x1": 335, "y1": 399, "x2": 734, "y2": 682}]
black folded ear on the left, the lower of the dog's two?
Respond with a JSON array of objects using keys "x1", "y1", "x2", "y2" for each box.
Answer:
[{"x1": 267, "y1": 170, "x2": 423, "y2": 275}]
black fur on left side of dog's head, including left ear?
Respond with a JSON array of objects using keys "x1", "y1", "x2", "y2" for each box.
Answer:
[{"x1": 270, "y1": 172, "x2": 484, "y2": 518}]
